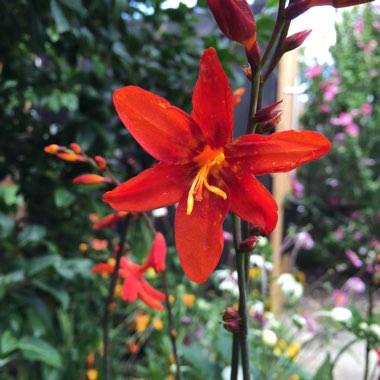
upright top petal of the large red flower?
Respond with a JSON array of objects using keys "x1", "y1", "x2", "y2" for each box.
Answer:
[{"x1": 191, "y1": 48, "x2": 234, "y2": 148}]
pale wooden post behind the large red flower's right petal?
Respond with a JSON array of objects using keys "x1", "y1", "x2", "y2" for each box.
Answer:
[{"x1": 271, "y1": 50, "x2": 298, "y2": 316}]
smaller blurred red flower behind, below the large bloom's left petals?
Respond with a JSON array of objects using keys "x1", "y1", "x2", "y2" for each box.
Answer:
[{"x1": 92, "y1": 233, "x2": 166, "y2": 310}]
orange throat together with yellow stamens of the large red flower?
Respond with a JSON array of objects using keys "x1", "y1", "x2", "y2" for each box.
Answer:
[{"x1": 186, "y1": 147, "x2": 227, "y2": 215}]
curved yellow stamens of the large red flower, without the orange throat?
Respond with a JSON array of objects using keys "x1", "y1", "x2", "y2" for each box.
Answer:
[{"x1": 186, "y1": 153, "x2": 227, "y2": 215}]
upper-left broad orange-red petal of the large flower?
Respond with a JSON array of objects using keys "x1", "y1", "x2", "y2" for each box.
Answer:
[{"x1": 113, "y1": 86, "x2": 204, "y2": 163}]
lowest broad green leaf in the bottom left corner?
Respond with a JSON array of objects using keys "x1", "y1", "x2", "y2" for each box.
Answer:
[{"x1": 17, "y1": 337, "x2": 62, "y2": 368}]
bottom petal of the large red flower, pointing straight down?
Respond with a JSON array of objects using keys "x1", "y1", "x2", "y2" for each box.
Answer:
[{"x1": 175, "y1": 185, "x2": 230, "y2": 284}]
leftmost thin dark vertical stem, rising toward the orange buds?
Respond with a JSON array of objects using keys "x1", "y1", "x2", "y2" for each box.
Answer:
[{"x1": 103, "y1": 217, "x2": 129, "y2": 380}]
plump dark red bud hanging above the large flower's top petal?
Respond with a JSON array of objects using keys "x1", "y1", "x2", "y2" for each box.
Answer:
[{"x1": 207, "y1": 0, "x2": 260, "y2": 63}]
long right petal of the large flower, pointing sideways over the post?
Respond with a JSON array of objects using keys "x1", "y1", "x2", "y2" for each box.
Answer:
[{"x1": 225, "y1": 131, "x2": 331, "y2": 175}]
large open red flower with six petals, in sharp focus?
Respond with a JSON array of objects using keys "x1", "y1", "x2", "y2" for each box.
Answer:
[{"x1": 103, "y1": 48, "x2": 330, "y2": 283}]
